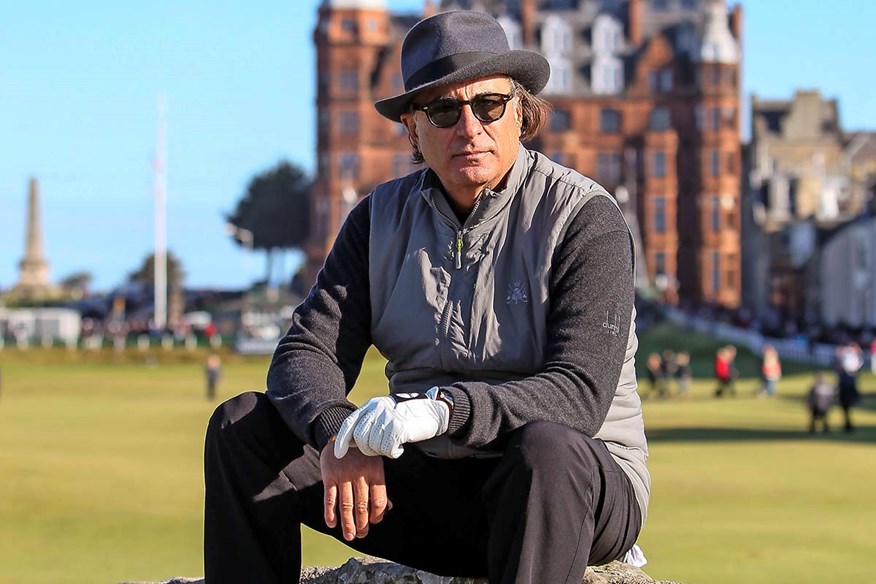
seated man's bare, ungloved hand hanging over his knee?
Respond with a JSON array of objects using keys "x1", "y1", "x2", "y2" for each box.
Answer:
[{"x1": 319, "y1": 440, "x2": 392, "y2": 541}]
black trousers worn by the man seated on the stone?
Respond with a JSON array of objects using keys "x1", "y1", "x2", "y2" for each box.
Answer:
[{"x1": 204, "y1": 392, "x2": 641, "y2": 584}]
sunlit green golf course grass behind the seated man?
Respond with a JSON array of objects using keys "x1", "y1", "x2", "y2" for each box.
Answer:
[{"x1": 0, "y1": 342, "x2": 876, "y2": 584}]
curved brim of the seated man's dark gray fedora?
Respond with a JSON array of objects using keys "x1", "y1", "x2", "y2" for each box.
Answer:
[{"x1": 374, "y1": 50, "x2": 551, "y2": 122}]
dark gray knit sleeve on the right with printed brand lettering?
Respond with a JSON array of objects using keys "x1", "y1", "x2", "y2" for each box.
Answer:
[{"x1": 444, "y1": 196, "x2": 635, "y2": 447}]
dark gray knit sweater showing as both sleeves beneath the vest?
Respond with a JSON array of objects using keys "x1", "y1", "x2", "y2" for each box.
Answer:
[{"x1": 267, "y1": 196, "x2": 634, "y2": 450}]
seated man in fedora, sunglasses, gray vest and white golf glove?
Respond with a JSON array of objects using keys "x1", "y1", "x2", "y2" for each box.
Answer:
[{"x1": 205, "y1": 11, "x2": 650, "y2": 584}]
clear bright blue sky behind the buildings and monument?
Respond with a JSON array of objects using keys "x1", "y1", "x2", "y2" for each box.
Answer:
[{"x1": 0, "y1": 0, "x2": 876, "y2": 290}]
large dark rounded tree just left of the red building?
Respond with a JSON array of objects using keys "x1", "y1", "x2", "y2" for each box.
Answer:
[{"x1": 225, "y1": 160, "x2": 311, "y2": 282}]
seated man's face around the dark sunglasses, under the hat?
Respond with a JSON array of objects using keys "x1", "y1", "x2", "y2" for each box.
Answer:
[{"x1": 402, "y1": 76, "x2": 520, "y2": 210}]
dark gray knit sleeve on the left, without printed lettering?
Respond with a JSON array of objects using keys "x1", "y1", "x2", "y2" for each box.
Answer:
[{"x1": 267, "y1": 197, "x2": 371, "y2": 450}]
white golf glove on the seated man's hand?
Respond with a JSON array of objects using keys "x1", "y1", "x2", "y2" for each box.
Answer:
[{"x1": 335, "y1": 387, "x2": 450, "y2": 458}]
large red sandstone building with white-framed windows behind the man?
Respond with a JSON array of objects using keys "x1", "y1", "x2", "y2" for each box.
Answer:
[{"x1": 308, "y1": 0, "x2": 742, "y2": 307}]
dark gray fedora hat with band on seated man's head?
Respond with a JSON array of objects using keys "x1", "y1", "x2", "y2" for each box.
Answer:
[{"x1": 374, "y1": 10, "x2": 551, "y2": 122}]
